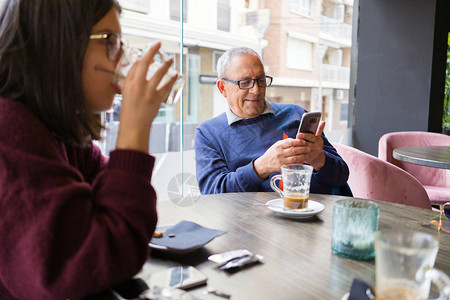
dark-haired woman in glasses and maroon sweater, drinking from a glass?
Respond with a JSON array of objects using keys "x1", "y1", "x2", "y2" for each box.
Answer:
[{"x1": 0, "y1": 0, "x2": 176, "y2": 300}]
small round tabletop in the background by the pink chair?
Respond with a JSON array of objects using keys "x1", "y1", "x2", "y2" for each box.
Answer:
[{"x1": 392, "y1": 146, "x2": 450, "y2": 169}]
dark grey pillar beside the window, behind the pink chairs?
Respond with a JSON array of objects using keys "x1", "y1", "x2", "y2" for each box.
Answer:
[{"x1": 353, "y1": 0, "x2": 450, "y2": 156}]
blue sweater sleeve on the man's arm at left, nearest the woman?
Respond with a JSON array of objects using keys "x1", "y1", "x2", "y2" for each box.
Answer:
[{"x1": 195, "y1": 128, "x2": 263, "y2": 194}]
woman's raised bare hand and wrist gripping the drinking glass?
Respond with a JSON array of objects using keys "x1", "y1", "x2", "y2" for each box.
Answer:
[{"x1": 116, "y1": 42, "x2": 178, "y2": 153}]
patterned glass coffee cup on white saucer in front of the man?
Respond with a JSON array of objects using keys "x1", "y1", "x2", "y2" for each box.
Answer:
[{"x1": 270, "y1": 165, "x2": 313, "y2": 210}]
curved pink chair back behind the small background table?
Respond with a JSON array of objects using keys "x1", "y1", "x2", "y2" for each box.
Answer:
[{"x1": 378, "y1": 131, "x2": 450, "y2": 187}]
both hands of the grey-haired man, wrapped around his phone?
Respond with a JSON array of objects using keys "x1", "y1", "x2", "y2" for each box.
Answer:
[{"x1": 253, "y1": 121, "x2": 325, "y2": 179}]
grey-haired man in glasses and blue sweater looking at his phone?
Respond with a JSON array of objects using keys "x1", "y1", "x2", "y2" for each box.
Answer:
[{"x1": 195, "y1": 48, "x2": 349, "y2": 194}]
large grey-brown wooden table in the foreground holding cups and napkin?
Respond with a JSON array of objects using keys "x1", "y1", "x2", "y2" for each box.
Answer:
[{"x1": 139, "y1": 193, "x2": 450, "y2": 300}]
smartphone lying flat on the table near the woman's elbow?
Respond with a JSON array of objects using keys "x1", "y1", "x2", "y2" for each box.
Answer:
[{"x1": 150, "y1": 266, "x2": 207, "y2": 290}]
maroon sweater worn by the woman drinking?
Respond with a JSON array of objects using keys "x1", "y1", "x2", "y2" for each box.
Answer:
[{"x1": 0, "y1": 97, "x2": 157, "y2": 300}]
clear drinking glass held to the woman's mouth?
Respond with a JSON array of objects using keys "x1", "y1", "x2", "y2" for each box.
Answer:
[{"x1": 114, "y1": 47, "x2": 184, "y2": 106}]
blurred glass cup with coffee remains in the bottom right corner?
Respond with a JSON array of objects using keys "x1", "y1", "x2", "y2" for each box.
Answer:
[{"x1": 375, "y1": 231, "x2": 450, "y2": 300}]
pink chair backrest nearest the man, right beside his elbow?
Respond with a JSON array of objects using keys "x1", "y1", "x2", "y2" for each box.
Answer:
[{"x1": 332, "y1": 143, "x2": 431, "y2": 209}]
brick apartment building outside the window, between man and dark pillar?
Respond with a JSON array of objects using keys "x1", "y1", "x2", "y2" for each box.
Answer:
[{"x1": 263, "y1": 0, "x2": 353, "y2": 131}]
